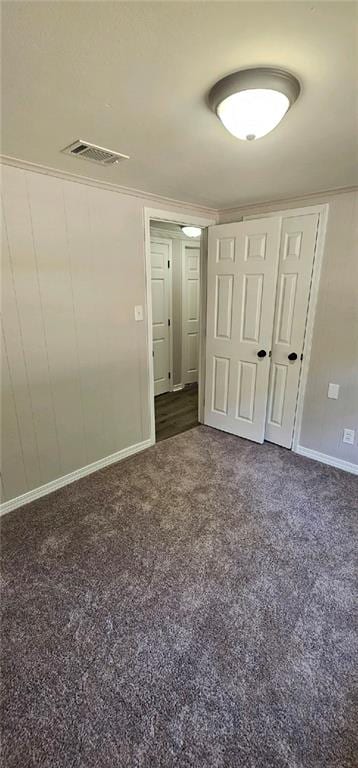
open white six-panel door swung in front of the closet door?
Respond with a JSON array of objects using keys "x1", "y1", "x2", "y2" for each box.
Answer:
[{"x1": 204, "y1": 218, "x2": 280, "y2": 443}]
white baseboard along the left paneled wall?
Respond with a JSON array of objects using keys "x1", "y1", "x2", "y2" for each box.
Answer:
[{"x1": 0, "y1": 440, "x2": 153, "y2": 515}]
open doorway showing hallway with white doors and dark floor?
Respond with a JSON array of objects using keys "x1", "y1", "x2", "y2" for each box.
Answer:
[{"x1": 150, "y1": 219, "x2": 201, "y2": 441}]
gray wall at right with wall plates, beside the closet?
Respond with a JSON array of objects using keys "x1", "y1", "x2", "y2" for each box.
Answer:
[{"x1": 220, "y1": 191, "x2": 358, "y2": 464}]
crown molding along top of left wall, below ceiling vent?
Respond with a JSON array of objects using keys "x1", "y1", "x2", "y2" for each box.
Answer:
[{"x1": 0, "y1": 155, "x2": 219, "y2": 217}]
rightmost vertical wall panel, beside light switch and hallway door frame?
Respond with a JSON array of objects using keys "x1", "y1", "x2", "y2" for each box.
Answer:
[{"x1": 88, "y1": 188, "x2": 145, "y2": 455}]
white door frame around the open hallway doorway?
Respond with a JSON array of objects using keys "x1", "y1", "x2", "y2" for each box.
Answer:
[{"x1": 144, "y1": 207, "x2": 217, "y2": 445}]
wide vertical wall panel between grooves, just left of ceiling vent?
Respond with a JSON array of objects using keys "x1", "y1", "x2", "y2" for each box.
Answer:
[{"x1": 28, "y1": 174, "x2": 86, "y2": 474}]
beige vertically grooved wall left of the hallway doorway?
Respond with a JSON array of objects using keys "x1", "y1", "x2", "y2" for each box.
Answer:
[{"x1": 2, "y1": 166, "x2": 213, "y2": 500}]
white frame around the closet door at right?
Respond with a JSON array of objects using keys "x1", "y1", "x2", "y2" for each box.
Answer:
[{"x1": 242, "y1": 203, "x2": 329, "y2": 453}]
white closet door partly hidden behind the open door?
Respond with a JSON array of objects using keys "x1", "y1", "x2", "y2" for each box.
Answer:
[{"x1": 265, "y1": 214, "x2": 318, "y2": 448}]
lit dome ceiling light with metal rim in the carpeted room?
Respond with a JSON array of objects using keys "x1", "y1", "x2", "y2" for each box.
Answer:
[{"x1": 209, "y1": 67, "x2": 301, "y2": 141}]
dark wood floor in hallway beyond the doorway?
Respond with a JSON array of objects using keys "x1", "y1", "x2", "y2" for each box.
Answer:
[{"x1": 154, "y1": 384, "x2": 198, "y2": 442}]
